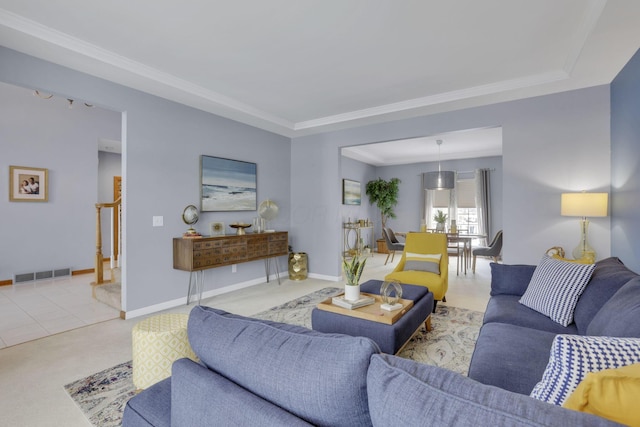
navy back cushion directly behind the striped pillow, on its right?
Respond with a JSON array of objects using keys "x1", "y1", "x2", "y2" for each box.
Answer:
[{"x1": 573, "y1": 257, "x2": 638, "y2": 335}]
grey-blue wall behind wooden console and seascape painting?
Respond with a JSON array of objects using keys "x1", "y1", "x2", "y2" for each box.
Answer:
[{"x1": 0, "y1": 48, "x2": 290, "y2": 311}]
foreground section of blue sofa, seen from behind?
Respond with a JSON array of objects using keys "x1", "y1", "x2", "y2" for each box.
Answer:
[{"x1": 123, "y1": 300, "x2": 617, "y2": 427}]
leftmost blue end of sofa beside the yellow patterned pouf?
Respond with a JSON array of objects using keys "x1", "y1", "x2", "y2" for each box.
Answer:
[{"x1": 122, "y1": 377, "x2": 171, "y2": 427}]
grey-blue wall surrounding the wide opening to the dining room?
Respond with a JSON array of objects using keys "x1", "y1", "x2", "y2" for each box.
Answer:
[{"x1": 291, "y1": 86, "x2": 611, "y2": 277}]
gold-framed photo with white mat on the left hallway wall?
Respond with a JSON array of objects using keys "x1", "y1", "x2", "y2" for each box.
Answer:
[{"x1": 9, "y1": 166, "x2": 49, "y2": 202}]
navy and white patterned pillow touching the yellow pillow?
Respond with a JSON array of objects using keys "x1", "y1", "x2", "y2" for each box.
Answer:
[{"x1": 531, "y1": 335, "x2": 640, "y2": 406}]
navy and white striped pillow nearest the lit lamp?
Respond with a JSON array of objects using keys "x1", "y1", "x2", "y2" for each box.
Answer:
[{"x1": 520, "y1": 255, "x2": 596, "y2": 326}]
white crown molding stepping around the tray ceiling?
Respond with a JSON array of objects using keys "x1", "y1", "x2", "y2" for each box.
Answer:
[{"x1": 0, "y1": 0, "x2": 608, "y2": 136}]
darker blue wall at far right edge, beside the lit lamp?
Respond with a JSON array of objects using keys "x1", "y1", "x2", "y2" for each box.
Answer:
[{"x1": 611, "y1": 47, "x2": 640, "y2": 272}]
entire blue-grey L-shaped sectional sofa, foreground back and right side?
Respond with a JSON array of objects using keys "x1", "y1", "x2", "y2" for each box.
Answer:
[{"x1": 123, "y1": 270, "x2": 637, "y2": 427}]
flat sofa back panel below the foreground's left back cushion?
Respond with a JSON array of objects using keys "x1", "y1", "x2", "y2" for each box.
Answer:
[{"x1": 171, "y1": 359, "x2": 311, "y2": 427}]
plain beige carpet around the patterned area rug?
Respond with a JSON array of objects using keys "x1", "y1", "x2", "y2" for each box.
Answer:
[{"x1": 0, "y1": 254, "x2": 490, "y2": 427}]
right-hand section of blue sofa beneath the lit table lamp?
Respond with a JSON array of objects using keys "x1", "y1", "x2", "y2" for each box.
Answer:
[{"x1": 469, "y1": 258, "x2": 640, "y2": 395}]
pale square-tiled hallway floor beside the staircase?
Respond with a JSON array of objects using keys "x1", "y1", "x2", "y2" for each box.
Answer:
[{"x1": 0, "y1": 274, "x2": 120, "y2": 349}]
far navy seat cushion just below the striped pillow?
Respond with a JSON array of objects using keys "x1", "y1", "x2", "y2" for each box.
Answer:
[{"x1": 483, "y1": 295, "x2": 578, "y2": 334}]
